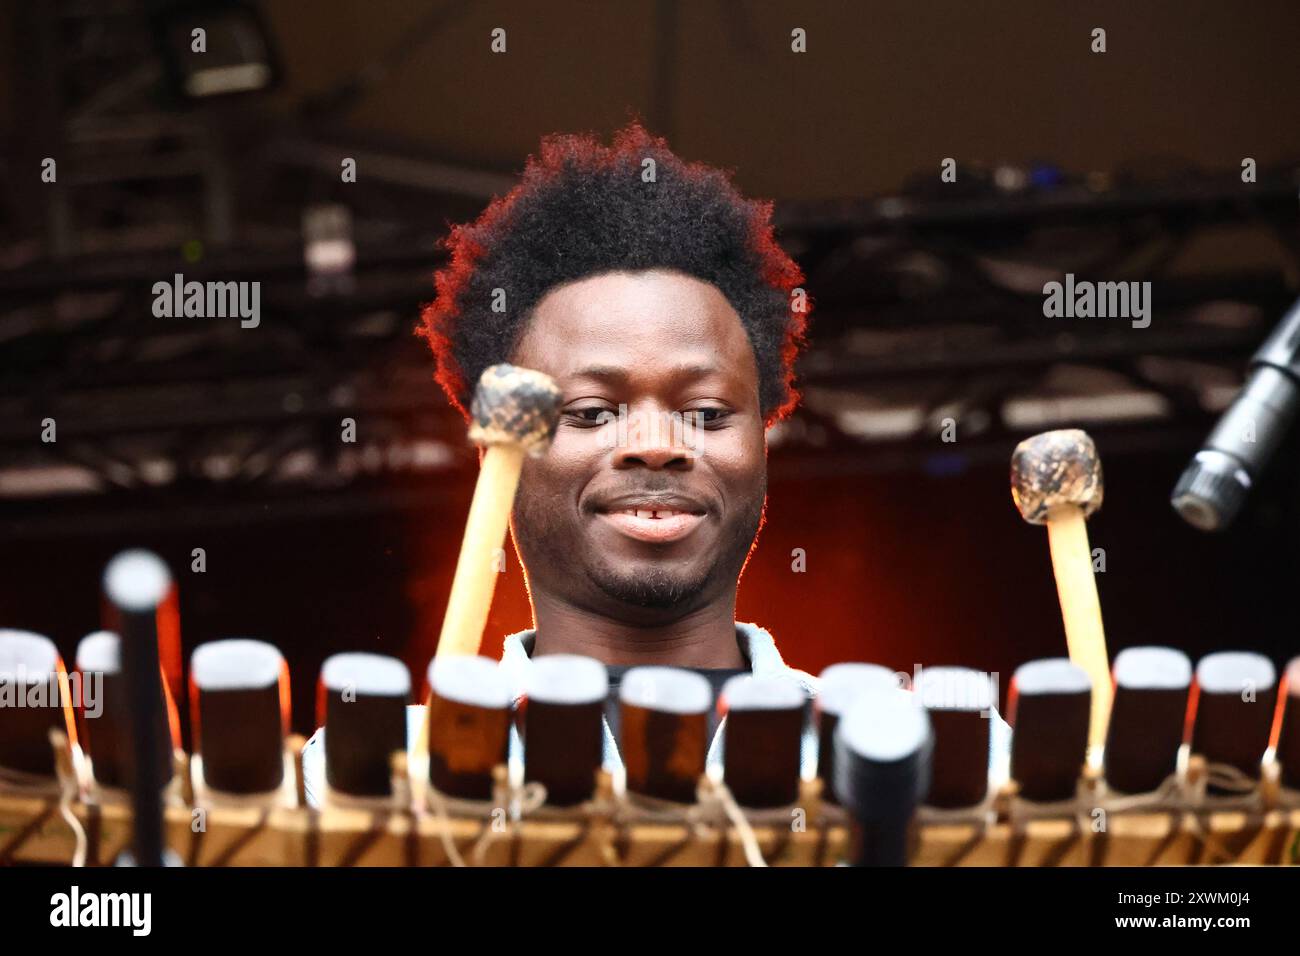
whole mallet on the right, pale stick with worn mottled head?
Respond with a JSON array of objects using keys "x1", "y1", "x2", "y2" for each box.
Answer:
[{"x1": 1011, "y1": 428, "x2": 1112, "y2": 762}]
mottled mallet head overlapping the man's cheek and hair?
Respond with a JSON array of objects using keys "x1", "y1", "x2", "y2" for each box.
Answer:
[{"x1": 469, "y1": 363, "x2": 562, "y2": 455}]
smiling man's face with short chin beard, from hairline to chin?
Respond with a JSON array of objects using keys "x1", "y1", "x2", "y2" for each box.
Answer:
[{"x1": 511, "y1": 271, "x2": 767, "y2": 623}]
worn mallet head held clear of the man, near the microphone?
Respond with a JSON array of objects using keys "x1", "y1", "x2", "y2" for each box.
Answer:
[{"x1": 1011, "y1": 428, "x2": 1102, "y2": 524}]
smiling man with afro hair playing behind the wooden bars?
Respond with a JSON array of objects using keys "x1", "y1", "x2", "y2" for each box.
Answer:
[{"x1": 301, "y1": 122, "x2": 1003, "y2": 806}]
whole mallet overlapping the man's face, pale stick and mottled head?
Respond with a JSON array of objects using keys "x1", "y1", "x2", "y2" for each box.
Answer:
[{"x1": 416, "y1": 364, "x2": 562, "y2": 752}]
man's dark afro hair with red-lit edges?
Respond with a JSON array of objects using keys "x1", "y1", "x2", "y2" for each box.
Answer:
[{"x1": 417, "y1": 120, "x2": 810, "y2": 424}]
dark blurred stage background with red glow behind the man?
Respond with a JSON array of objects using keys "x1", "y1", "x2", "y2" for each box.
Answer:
[{"x1": 0, "y1": 0, "x2": 1300, "y2": 731}]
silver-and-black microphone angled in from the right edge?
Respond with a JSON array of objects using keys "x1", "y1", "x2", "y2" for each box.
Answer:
[{"x1": 1170, "y1": 302, "x2": 1300, "y2": 531}]
